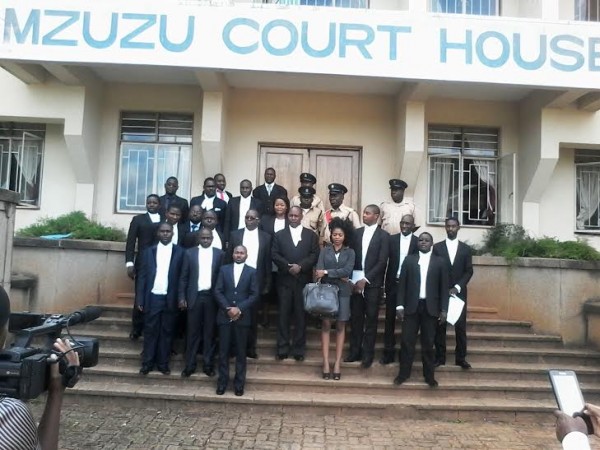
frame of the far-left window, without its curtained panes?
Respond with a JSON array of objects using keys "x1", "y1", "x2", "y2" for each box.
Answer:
[{"x1": 0, "y1": 121, "x2": 47, "y2": 209}]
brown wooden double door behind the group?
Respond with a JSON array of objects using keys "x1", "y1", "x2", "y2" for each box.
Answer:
[{"x1": 257, "y1": 144, "x2": 360, "y2": 211}]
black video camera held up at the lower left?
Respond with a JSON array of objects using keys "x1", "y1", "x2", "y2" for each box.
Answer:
[{"x1": 0, "y1": 306, "x2": 102, "y2": 400}]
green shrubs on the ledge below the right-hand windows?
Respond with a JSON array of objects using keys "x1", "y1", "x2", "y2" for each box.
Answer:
[{"x1": 476, "y1": 224, "x2": 600, "y2": 261}]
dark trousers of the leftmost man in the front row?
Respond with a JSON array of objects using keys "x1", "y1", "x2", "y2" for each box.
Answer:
[{"x1": 142, "y1": 294, "x2": 177, "y2": 369}]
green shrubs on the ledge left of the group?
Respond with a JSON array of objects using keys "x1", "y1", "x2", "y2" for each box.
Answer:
[{"x1": 17, "y1": 211, "x2": 126, "y2": 242}]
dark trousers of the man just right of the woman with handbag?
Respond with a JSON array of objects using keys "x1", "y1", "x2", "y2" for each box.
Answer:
[{"x1": 350, "y1": 287, "x2": 381, "y2": 362}]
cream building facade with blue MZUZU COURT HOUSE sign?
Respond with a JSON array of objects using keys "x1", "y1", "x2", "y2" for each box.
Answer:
[{"x1": 0, "y1": 0, "x2": 600, "y2": 248}]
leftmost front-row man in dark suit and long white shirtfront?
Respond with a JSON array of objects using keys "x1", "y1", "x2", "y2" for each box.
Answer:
[{"x1": 135, "y1": 222, "x2": 184, "y2": 375}]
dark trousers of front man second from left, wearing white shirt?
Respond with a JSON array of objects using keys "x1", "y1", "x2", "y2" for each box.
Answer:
[{"x1": 185, "y1": 291, "x2": 217, "y2": 370}]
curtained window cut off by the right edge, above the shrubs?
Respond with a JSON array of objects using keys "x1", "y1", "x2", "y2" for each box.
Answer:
[{"x1": 575, "y1": 150, "x2": 600, "y2": 231}]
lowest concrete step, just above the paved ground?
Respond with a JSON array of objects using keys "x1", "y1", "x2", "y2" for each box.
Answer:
[{"x1": 67, "y1": 380, "x2": 556, "y2": 424}]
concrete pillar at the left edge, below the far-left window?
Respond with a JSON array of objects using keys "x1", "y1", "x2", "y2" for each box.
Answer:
[{"x1": 0, "y1": 189, "x2": 19, "y2": 296}]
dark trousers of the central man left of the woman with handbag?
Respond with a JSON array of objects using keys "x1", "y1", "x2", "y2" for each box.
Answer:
[{"x1": 277, "y1": 279, "x2": 306, "y2": 356}]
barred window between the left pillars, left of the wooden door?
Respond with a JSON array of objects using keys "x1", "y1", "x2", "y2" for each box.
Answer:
[{"x1": 117, "y1": 112, "x2": 194, "y2": 212}]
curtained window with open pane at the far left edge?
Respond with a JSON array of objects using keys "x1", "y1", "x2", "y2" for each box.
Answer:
[{"x1": 0, "y1": 122, "x2": 46, "y2": 206}]
